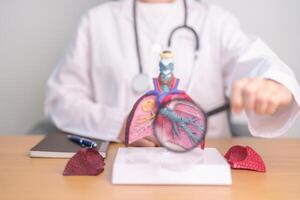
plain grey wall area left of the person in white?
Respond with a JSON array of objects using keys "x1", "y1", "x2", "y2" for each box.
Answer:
[{"x1": 0, "y1": 0, "x2": 101, "y2": 134}]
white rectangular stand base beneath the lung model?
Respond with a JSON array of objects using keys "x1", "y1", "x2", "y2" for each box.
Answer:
[{"x1": 112, "y1": 147, "x2": 232, "y2": 185}]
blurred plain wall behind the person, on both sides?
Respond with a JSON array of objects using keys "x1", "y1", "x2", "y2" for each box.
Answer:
[{"x1": 0, "y1": 0, "x2": 300, "y2": 137}]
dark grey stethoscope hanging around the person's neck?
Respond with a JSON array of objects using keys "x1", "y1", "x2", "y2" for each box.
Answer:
[{"x1": 132, "y1": 0, "x2": 200, "y2": 94}]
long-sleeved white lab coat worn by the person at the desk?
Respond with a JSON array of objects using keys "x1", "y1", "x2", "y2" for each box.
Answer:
[{"x1": 45, "y1": 0, "x2": 300, "y2": 141}]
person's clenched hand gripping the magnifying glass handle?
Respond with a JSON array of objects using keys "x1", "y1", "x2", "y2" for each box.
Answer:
[{"x1": 230, "y1": 78, "x2": 293, "y2": 115}]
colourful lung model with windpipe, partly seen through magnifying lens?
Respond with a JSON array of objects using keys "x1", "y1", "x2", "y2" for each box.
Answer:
[{"x1": 125, "y1": 51, "x2": 206, "y2": 152}]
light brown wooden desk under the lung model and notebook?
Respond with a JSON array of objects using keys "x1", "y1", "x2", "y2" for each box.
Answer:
[{"x1": 0, "y1": 136, "x2": 300, "y2": 200}]
